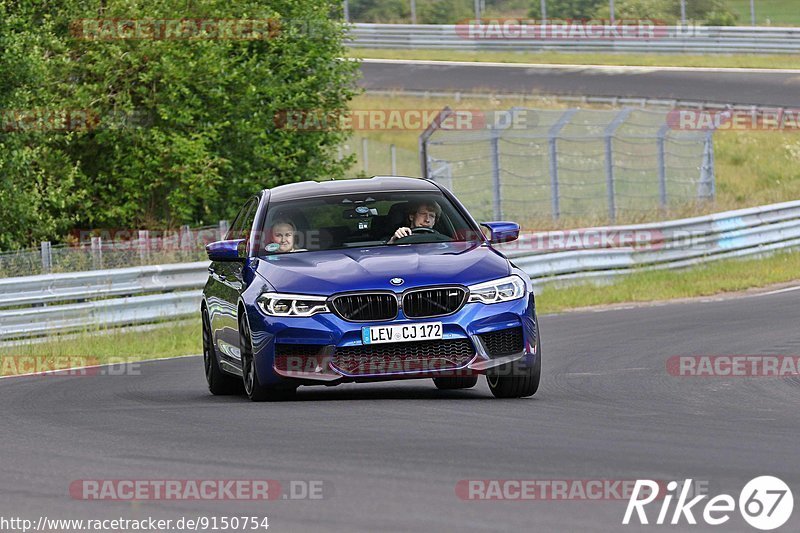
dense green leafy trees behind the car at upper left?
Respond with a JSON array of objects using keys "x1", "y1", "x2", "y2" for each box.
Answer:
[{"x1": 0, "y1": 0, "x2": 358, "y2": 247}]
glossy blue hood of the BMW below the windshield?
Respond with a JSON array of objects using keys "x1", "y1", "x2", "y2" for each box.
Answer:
[{"x1": 256, "y1": 242, "x2": 510, "y2": 295}]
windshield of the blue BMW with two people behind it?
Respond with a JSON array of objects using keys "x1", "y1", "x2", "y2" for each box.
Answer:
[{"x1": 258, "y1": 191, "x2": 479, "y2": 255}]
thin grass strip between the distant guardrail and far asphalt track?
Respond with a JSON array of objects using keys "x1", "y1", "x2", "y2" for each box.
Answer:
[{"x1": 350, "y1": 48, "x2": 800, "y2": 69}]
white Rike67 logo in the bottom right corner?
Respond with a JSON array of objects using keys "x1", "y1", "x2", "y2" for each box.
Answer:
[{"x1": 622, "y1": 476, "x2": 794, "y2": 531}]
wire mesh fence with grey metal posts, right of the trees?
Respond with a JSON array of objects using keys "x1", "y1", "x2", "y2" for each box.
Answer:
[{"x1": 420, "y1": 108, "x2": 715, "y2": 222}]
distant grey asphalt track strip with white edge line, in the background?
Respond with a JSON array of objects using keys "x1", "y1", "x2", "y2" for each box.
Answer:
[{"x1": 361, "y1": 59, "x2": 800, "y2": 107}]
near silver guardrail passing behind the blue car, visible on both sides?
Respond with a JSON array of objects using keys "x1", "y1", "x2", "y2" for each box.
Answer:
[{"x1": 0, "y1": 201, "x2": 800, "y2": 340}]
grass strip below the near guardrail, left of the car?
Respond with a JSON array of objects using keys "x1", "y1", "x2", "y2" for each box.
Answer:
[{"x1": 0, "y1": 317, "x2": 202, "y2": 375}]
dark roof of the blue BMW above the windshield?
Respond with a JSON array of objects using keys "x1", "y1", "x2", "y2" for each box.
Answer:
[{"x1": 265, "y1": 176, "x2": 439, "y2": 201}]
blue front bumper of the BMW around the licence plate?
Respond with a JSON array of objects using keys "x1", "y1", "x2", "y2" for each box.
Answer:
[{"x1": 247, "y1": 294, "x2": 540, "y2": 385}]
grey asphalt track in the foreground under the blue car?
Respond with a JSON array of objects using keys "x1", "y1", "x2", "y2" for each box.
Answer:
[{"x1": 0, "y1": 290, "x2": 800, "y2": 532}]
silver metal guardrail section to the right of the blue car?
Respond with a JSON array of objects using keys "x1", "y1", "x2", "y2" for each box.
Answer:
[{"x1": 499, "y1": 201, "x2": 800, "y2": 283}]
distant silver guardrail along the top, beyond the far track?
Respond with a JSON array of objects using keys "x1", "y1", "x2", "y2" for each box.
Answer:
[{"x1": 349, "y1": 21, "x2": 800, "y2": 54}]
